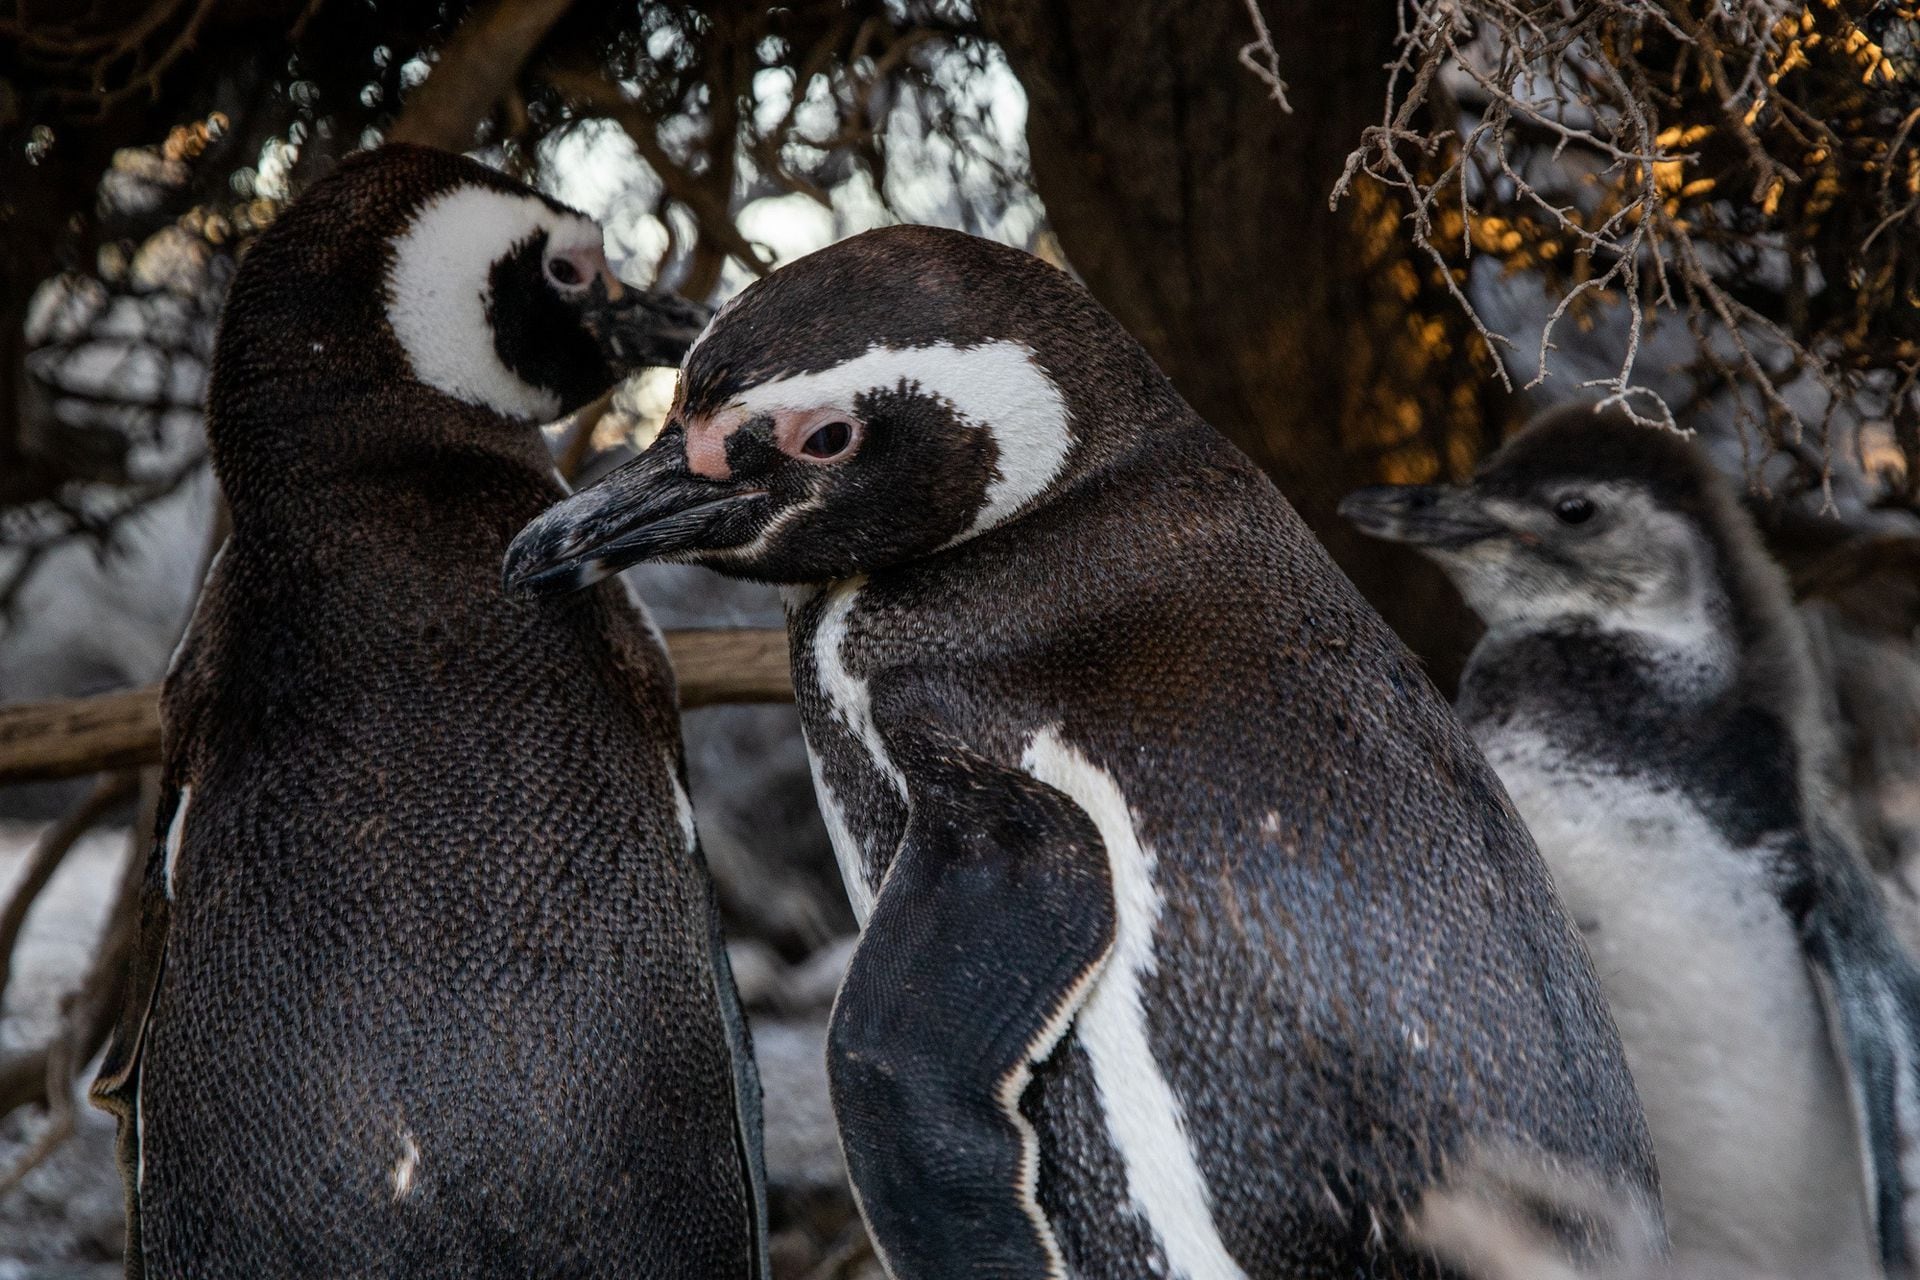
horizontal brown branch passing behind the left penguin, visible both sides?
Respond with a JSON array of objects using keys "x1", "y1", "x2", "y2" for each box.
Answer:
[{"x1": 0, "y1": 628, "x2": 793, "y2": 785}]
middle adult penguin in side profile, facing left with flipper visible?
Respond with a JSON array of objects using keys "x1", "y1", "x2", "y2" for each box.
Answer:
[{"x1": 507, "y1": 226, "x2": 1655, "y2": 1280}]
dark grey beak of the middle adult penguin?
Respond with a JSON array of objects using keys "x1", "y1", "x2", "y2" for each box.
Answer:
[{"x1": 503, "y1": 426, "x2": 770, "y2": 595}]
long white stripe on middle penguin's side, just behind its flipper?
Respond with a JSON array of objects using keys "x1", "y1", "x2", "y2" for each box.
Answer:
[{"x1": 1021, "y1": 729, "x2": 1246, "y2": 1280}]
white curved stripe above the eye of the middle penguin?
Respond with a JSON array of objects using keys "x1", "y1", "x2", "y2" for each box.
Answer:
[{"x1": 730, "y1": 340, "x2": 1073, "y2": 533}]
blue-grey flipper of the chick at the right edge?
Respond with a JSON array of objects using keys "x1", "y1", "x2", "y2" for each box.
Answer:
[{"x1": 1801, "y1": 836, "x2": 1920, "y2": 1278}]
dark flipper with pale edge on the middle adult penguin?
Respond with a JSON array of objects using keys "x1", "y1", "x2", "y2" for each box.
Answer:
[{"x1": 828, "y1": 743, "x2": 1114, "y2": 1280}]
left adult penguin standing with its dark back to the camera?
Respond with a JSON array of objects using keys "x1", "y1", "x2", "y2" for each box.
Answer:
[{"x1": 96, "y1": 148, "x2": 764, "y2": 1280}]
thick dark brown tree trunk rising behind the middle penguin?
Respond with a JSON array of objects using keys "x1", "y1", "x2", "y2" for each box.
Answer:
[{"x1": 981, "y1": 0, "x2": 1490, "y2": 687}]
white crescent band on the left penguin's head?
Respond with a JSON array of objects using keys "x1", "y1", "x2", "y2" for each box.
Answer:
[{"x1": 386, "y1": 186, "x2": 601, "y2": 422}]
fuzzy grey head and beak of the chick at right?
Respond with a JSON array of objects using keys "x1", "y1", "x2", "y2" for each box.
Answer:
[{"x1": 1340, "y1": 405, "x2": 1753, "y2": 643}]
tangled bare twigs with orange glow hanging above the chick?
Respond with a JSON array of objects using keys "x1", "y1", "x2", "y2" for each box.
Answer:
[{"x1": 1334, "y1": 0, "x2": 1920, "y2": 495}]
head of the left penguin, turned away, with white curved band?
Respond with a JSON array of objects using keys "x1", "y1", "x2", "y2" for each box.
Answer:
[{"x1": 209, "y1": 144, "x2": 705, "y2": 487}]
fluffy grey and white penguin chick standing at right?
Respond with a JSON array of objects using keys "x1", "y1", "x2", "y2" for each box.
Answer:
[{"x1": 1342, "y1": 405, "x2": 1920, "y2": 1276}]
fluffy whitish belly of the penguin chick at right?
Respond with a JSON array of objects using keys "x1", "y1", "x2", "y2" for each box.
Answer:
[{"x1": 1482, "y1": 735, "x2": 1874, "y2": 1280}]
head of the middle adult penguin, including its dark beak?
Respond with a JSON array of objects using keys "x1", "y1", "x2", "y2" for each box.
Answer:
[{"x1": 507, "y1": 226, "x2": 1177, "y2": 591}]
